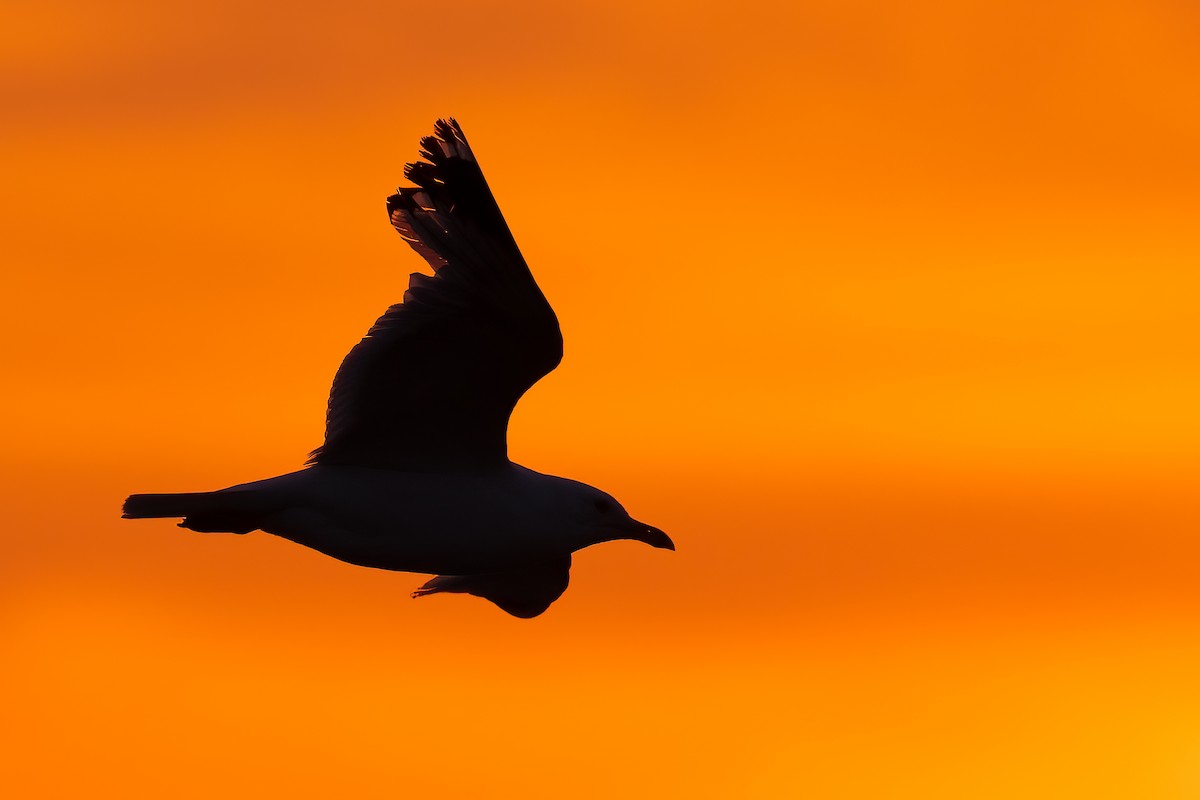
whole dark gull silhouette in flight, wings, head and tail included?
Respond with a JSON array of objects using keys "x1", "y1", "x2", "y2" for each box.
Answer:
[{"x1": 122, "y1": 119, "x2": 674, "y2": 618}]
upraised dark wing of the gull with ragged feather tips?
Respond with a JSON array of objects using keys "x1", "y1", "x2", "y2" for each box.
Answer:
[{"x1": 310, "y1": 120, "x2": 563, "y2": 471}]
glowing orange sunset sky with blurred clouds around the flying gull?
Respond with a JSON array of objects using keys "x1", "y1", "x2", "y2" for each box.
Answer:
[{"x1": 0, "y1": 0, "x2": 1200, "y2": 799}]
